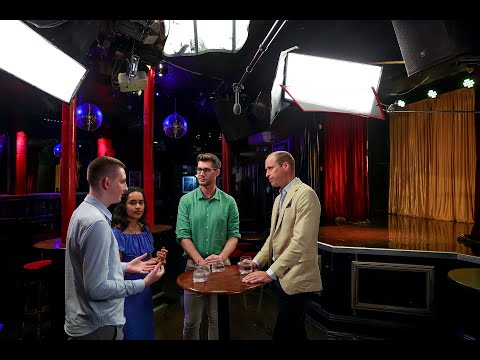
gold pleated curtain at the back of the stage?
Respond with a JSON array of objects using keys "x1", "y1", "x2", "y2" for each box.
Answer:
[{"x1": 388, "y1": 89, "x2": 476, "y2": 223}]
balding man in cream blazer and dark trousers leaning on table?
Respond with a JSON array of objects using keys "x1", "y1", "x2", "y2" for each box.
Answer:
[{"x1": 243, "y1": 151, "x2": 322, "y2": 341}]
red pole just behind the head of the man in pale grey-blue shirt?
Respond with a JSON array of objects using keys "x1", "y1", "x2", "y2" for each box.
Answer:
[{"x1": 60, "y1": 96, "x2": 77, "y2": 240}]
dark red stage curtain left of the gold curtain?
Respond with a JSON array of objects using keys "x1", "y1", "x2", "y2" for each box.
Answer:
[{"x1": 322, "y1": 113, "x2": 369, "y2": 221}]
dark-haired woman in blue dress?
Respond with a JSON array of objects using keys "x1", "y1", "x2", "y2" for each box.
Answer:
[{"x1": 112, "y1": 187, "x2": 168, "y2": 340}]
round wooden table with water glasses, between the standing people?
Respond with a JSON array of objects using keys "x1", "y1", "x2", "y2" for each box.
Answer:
[{"x1": 177, "y1": 265, "x2": 265, "y2": 340}]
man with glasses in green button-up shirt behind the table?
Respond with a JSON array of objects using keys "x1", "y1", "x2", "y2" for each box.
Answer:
[{"x1": 175, "y1": 153, "x2": 240, "y2": 340}]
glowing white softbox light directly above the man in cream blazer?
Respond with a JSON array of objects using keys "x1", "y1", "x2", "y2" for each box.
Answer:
[{"x1": 270, "y1": 48, "x2": 384, "y2": 122}]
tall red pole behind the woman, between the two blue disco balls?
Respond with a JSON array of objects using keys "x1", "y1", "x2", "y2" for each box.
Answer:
[{"x1": 143, "y1": 67, "x2": 155, "y2": 226}]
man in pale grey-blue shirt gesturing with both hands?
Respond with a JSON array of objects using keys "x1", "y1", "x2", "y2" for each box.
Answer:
[{"x1": 64, "y1": 156, "x2": 165, "y2": 340}]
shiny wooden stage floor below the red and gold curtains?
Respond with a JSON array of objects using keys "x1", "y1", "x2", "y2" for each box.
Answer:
[{"x1": 319, "y1": 215, "x2": 473, "y2": 255}]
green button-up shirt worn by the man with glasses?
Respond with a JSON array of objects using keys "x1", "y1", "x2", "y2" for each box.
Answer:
[{"x1": 175, "y1": 187, "x2": 240, "y2": 258}]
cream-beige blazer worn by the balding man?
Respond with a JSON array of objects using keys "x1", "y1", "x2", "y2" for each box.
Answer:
[{"x1": 255, "y1": 178, "x2": 322, "y2": 295}]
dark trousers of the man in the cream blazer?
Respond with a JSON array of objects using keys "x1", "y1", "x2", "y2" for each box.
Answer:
[{"x1": 272, "y1": 280, "x2": 308, "y2": 341}]
